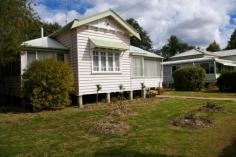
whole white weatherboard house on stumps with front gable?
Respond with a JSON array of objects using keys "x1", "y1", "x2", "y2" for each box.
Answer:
[{"x1": 0, "y1": 10, "x2": 163, "y2": 104}]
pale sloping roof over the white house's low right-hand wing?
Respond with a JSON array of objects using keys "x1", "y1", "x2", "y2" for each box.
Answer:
[{"x1": 129, "y1": 45, "x2": 163, "y2": 58}]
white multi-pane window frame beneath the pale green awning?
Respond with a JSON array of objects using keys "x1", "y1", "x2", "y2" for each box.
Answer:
[{"x1": 90, "y1": 48, "x2": 122, "y2": 74}]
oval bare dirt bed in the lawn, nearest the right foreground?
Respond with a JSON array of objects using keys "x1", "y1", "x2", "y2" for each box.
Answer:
[{"x1": 173, "y1": 113, "x2": 212, "y2": 128}]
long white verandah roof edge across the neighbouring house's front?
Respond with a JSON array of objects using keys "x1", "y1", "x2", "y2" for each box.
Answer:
[{"x1": 163, "y1": 57, "x2": 236, "y2": 66}]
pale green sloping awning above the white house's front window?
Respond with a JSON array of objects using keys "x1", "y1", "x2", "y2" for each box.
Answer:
[{"x1": 89, "y1": 38, "x2": 129, "y2": 50}]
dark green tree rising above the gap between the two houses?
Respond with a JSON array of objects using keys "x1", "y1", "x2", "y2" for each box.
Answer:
[{"x1": 161, "y1": 35, "x2": 194, "y2": 58}]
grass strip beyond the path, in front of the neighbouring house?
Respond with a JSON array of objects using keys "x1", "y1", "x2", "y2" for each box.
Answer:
[{"x1": 164, "y1": 89, "x2": 236, "y2": 98}]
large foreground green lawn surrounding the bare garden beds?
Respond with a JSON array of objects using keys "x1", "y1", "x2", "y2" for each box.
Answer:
[{"x1": 0, "y1": 99, "x2": 236, "y2": 157}]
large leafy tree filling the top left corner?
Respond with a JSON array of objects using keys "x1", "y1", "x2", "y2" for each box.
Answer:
[{"x1": 0, "y1": 0, "x2": 37, "y2": 64}]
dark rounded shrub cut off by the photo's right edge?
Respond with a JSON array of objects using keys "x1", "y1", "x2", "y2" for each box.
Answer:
[{"x1": 216, "y1": 71, "x2": 236, "y2": 92}]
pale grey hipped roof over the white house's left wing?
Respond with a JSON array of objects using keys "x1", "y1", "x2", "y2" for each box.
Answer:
[{"x1": 21, "y1": 37, "x2": 68, "y2": 50}]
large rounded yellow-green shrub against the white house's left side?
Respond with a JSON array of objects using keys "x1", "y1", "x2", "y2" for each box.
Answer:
[{"x1": 23, "y1": 59, "x2": 74, "y2": 110}]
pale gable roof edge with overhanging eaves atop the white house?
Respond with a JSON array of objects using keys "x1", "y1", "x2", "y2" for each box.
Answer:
[{"x1": 50, "y1": 9, "x2": 140, "y2": 39}]
